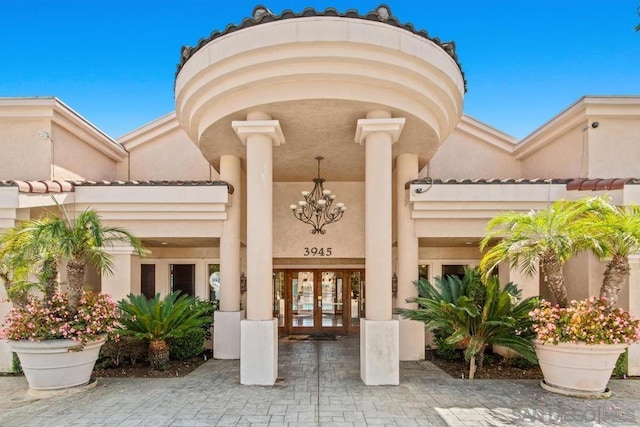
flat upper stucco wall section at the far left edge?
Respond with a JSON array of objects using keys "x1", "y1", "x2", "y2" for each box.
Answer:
[{"x1": 0, "y1": 119, "x2": 51, "y2": 180}]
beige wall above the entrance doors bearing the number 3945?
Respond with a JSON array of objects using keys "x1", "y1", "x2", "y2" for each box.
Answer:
[{"x1": 273, "y1": 182, "x2": 364, "y2": 262}]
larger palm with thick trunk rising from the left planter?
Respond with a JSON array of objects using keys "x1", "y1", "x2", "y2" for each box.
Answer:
[{"x1": 19, "y1": 205, "x2": 142, "y2": 310}]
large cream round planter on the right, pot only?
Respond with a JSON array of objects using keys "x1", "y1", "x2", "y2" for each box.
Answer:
[{"x1": 535, "y1": 341, "x2": 627, "y2": 397}]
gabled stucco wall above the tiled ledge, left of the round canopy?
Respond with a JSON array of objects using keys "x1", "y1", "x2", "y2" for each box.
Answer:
[{"x1": 118, "y1": 129, "x2": 215, "y2": 180}]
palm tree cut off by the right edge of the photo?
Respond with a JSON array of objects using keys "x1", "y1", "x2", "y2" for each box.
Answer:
[{"x1": 584, "y1": 200, "x2": 640, "y2": 304}]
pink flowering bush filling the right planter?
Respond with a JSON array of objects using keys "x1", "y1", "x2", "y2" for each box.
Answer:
[{"x1": 529, "y1": 297, "x2": 640, "y2": 344}]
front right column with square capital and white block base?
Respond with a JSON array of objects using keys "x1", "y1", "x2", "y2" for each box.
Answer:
[{"x1": 356, "y1": 110, "x2": 404, "y2": 385}]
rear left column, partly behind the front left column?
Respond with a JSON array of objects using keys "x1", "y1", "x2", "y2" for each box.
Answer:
[{"x1": 213, "y1": 155, "x2": 244, "y2": 359}]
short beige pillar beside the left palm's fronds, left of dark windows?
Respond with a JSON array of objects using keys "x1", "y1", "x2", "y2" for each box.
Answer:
[{"x1": 101, "y1": 246, "x2": 141, "y2": 301}]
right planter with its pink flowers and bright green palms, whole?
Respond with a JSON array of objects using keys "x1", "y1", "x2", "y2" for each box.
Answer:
[{"x1": 480, "y1": 197, "x2": 640, "y2": 397}]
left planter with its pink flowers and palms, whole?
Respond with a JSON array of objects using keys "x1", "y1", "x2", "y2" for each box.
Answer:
[{"x1": 0, "y1": 206, "x2": 142, "y2": 395}]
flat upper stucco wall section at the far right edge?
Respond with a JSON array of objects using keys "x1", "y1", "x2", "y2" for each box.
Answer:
[{"x1": 587, "y1": 117, "x2": 640, "y2": 178}]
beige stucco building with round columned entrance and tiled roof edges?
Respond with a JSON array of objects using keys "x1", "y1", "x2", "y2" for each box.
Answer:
[{"x1": 0, "y1": 6, "x2": 640, "y2": 385}]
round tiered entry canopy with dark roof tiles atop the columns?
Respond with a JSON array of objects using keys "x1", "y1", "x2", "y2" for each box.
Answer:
[{"x1": 175, "y1": 6, "x2": 465, "y2": 181}]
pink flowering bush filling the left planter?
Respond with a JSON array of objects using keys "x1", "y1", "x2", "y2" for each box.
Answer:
[{"x1": 0, "y1": 291, "x2": 119, "y2": 343}]
